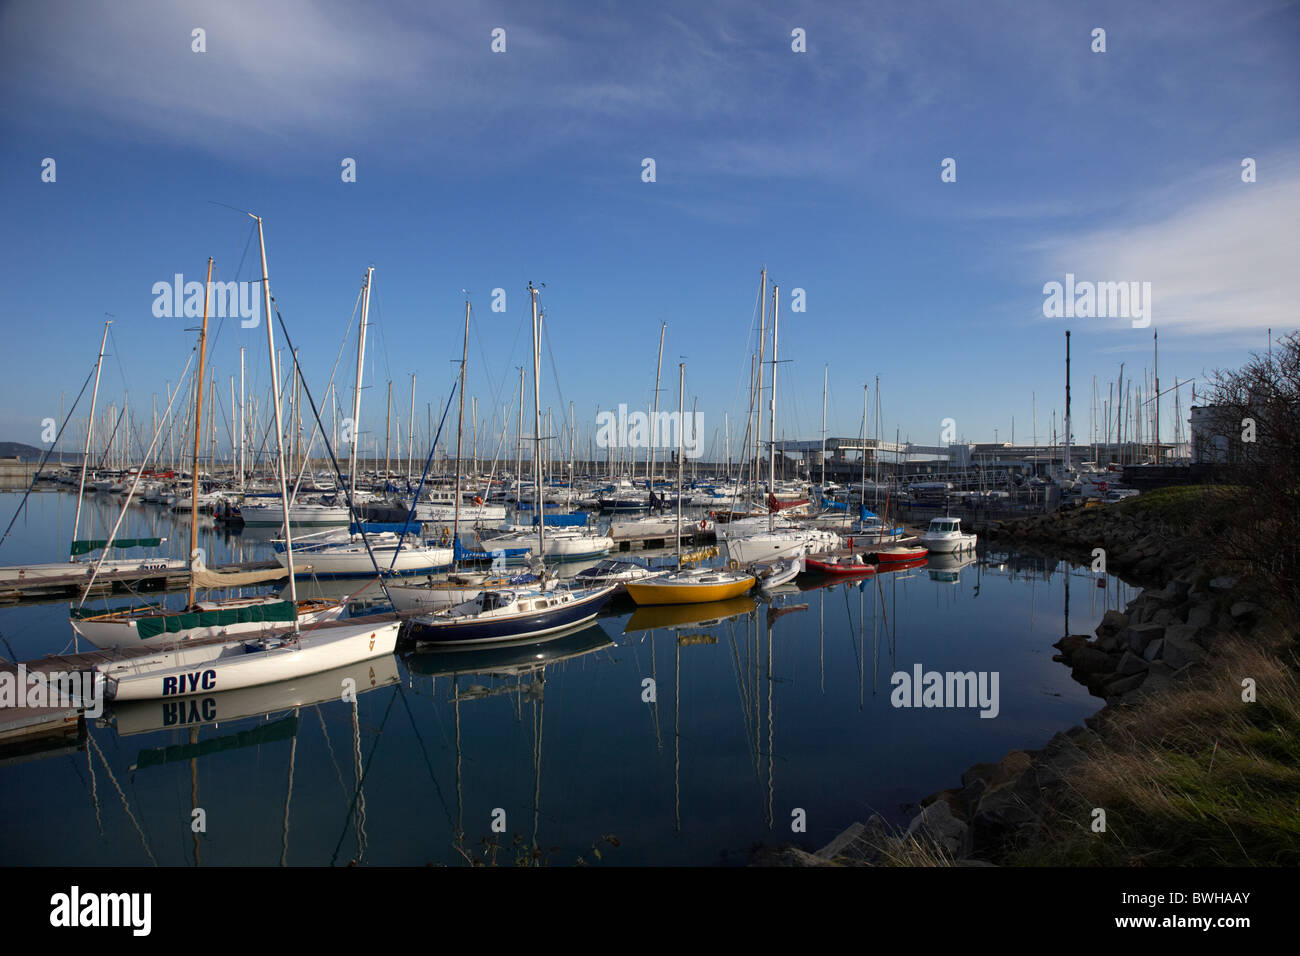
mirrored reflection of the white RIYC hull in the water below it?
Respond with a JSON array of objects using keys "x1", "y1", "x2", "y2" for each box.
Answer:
[{"x1": 112, "y1": 654, "x2": 399, "y2": 736}]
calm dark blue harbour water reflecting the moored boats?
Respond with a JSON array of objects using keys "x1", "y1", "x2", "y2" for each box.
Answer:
[{"x1": 0, "y1": 493, "x2": 1131, "y2": 866}]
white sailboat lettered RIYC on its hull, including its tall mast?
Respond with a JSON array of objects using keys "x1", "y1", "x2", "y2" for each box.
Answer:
[{"x1": 95, "y1": 216, "x2": 402, "y2": 700}]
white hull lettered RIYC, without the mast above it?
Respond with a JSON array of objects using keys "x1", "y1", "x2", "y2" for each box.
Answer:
[{"x1": 95, "y1": 620, "x2": 400, "y2": 700}]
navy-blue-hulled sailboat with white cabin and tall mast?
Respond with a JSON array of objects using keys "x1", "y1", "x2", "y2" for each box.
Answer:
[{"x1": 411, "y1": 282, "x2": 615, "y2": 644}]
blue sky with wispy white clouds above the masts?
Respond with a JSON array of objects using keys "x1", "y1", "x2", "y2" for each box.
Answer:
[{"x1": 0, "y1": 0, "x2": 1300, "y2": 463}]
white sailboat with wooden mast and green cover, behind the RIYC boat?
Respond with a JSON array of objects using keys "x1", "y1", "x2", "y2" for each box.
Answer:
[{"x1": 72, "y1": 259, "x2": 345, "y2": 649}]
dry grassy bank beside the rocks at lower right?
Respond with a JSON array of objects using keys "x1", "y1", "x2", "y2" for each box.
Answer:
[{"x1": 1005, "y1": 627, "x2": 1300, "y2": 866}]
